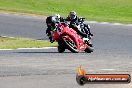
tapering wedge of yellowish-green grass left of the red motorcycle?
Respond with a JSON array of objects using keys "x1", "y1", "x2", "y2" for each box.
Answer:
[{"x1": 0, "y1": 37, "x2": 57, "y2": 49}]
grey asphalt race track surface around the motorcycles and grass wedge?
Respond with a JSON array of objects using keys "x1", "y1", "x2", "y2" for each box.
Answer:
[{"x1": 0, "y1": 14, "x2": 132, "y2": 88}]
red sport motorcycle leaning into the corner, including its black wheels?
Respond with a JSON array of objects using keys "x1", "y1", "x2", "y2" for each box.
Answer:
[{"x1": 51, "y1": 23, "x2": 93, "y2": 53}]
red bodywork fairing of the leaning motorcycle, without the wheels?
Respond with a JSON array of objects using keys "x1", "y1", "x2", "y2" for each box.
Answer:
[{"x1": 51, "y1": 23, "x2": 93, "y2": 52}]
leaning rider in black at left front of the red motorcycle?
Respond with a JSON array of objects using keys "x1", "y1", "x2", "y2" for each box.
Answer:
[{"x1": 46, "y1": 14, "x2": 60, "y2": 43}]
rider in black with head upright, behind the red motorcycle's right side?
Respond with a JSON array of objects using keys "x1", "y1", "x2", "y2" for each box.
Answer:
[{"x1": 65, "y1": 11, "x2": 93, "y2": 45}]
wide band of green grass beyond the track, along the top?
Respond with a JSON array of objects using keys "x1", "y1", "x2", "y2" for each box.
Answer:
[{"x1": 0, "y1": 0, "x2": 132, "y2": 23}]
